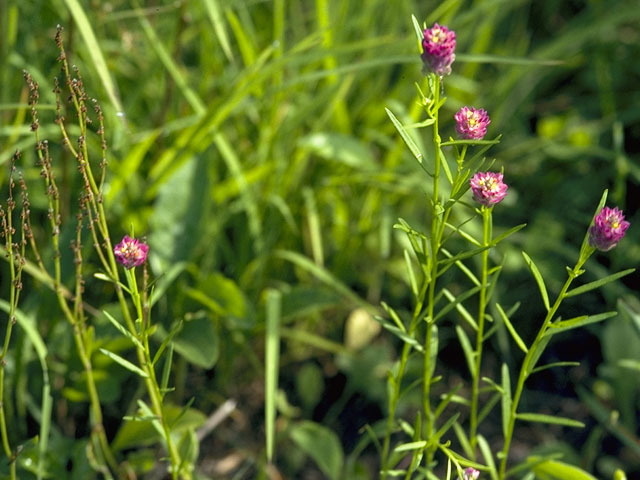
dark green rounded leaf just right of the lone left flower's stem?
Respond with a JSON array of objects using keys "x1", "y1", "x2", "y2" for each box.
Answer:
[{"x1": 173, "y1": 313, "x2": 220, "y2": 369}]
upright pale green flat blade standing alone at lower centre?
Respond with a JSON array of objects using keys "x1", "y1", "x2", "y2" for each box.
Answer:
[{"x1": 264, "y1": 290, "x2": 282, "y2": 462}]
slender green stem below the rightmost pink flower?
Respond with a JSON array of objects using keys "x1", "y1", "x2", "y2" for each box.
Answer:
[{"x1": 498, "y1": 255, "x2": 588, "y2": 480}]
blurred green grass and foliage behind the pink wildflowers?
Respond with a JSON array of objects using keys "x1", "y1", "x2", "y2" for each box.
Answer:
[{"x1": 0, "y1": 0, "x2": 640, "y2": 478}]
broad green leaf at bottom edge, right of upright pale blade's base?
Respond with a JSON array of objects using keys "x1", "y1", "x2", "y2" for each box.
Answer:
[{"x1": 289, "y1": 421, "x2": 344, "y2": 480}]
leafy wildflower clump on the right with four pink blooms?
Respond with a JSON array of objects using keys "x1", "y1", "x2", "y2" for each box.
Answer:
[{"x1": 379, "y1": 18, "x2": 633, "y2": 480}]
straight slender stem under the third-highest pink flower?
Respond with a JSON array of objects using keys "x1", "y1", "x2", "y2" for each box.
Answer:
[{"x1": 465, "y1": 205, "x2": 492, "y2": 455}]
